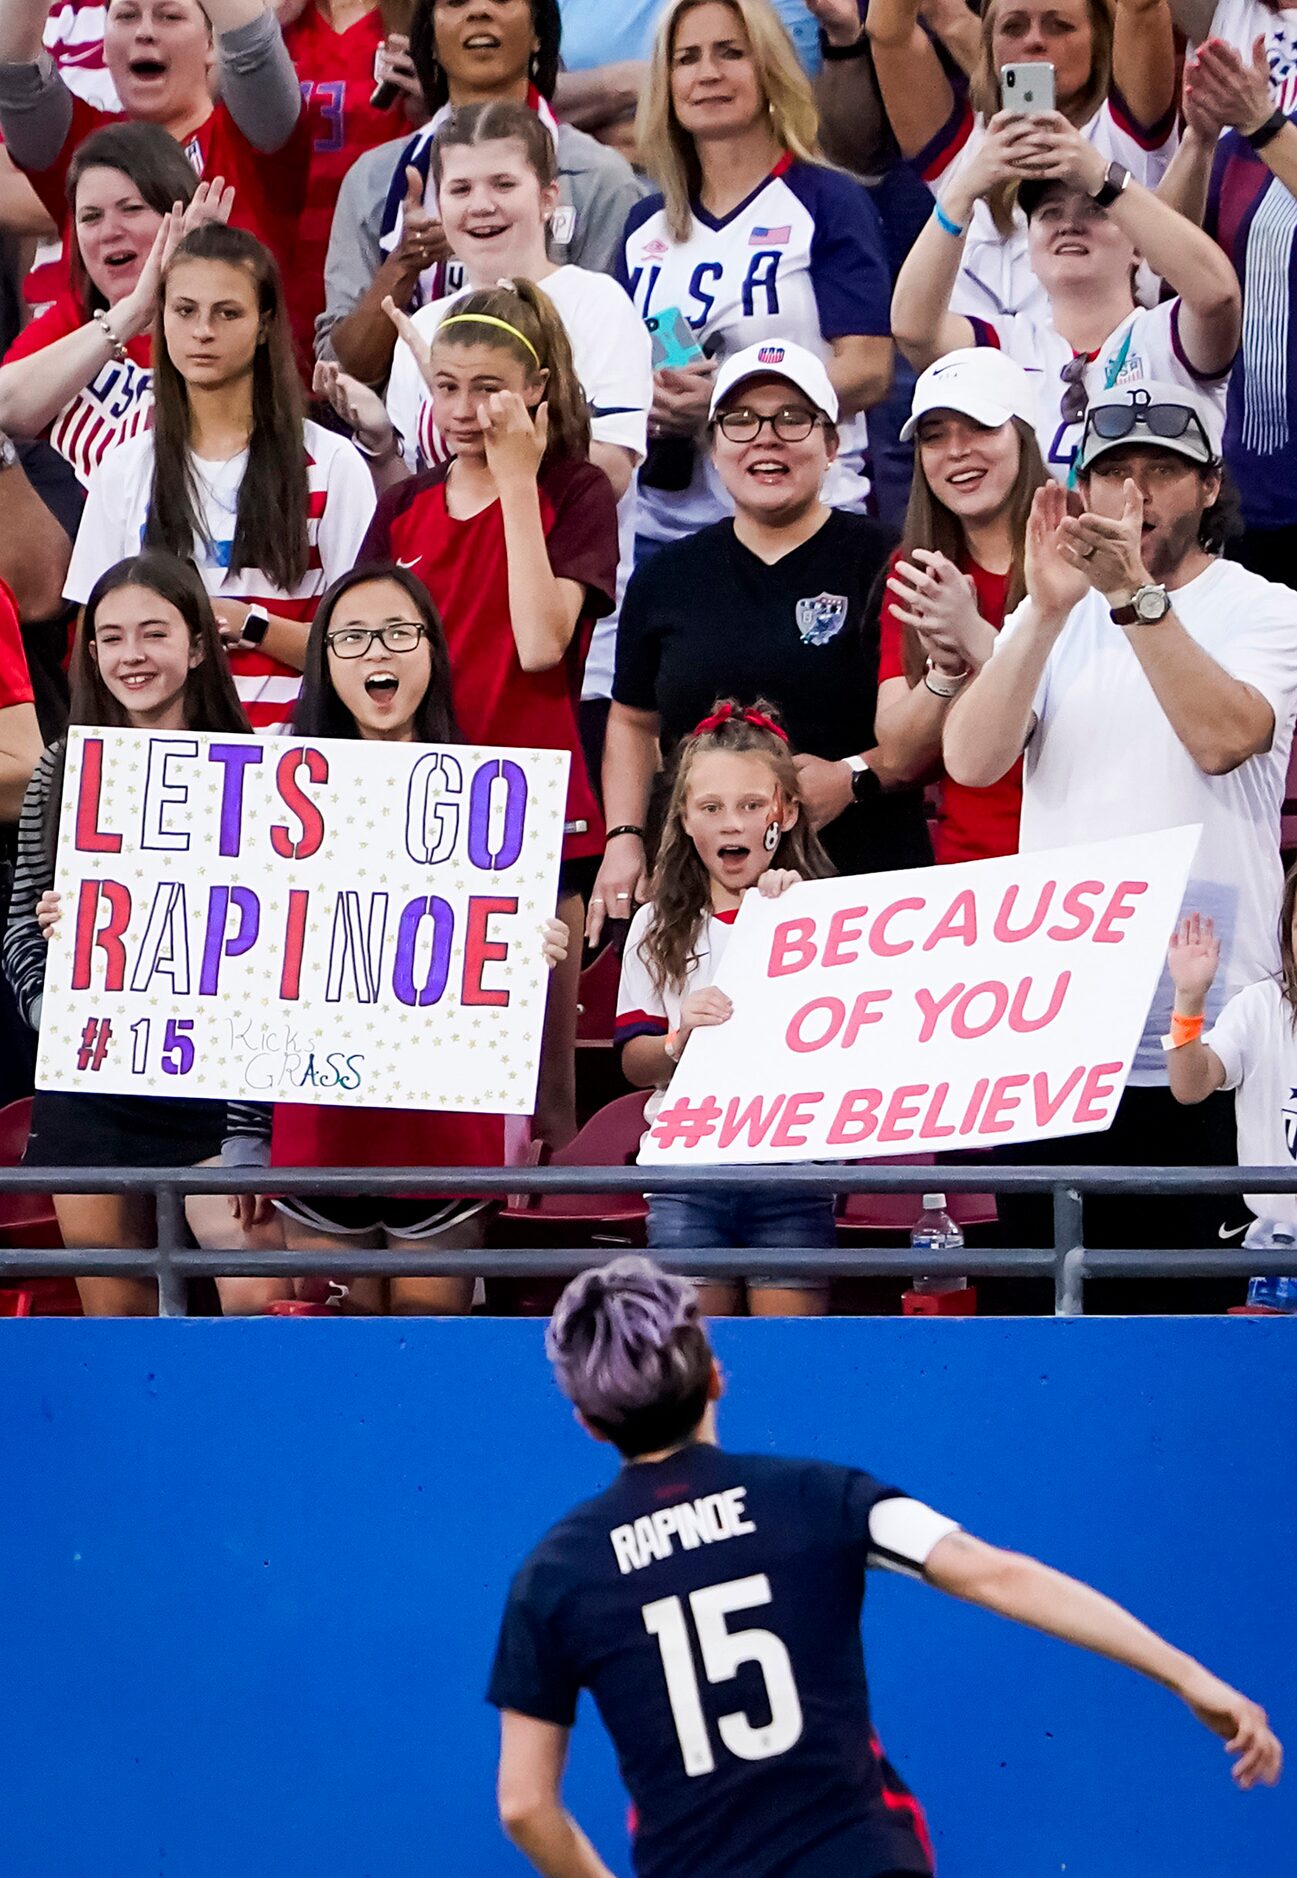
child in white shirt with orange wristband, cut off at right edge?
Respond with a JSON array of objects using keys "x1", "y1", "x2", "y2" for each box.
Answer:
[{"x1": 1162, "y1": 901, "x2": 1297, "y2": 1224}]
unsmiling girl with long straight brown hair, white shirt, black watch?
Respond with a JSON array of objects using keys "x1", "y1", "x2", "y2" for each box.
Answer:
[{"x1": 64, "y1": 223, "x2": 374, "y2": 731}]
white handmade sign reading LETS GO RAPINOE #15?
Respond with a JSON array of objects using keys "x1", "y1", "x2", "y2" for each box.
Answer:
[{"x1": 36, "y1": 731, "x2": 569, "y2": 1114}]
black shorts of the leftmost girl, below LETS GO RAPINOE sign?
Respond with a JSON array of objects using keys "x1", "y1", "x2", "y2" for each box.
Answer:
[{"x1": 23, "y1": 1089, "x2": 227, "y2": 1168}]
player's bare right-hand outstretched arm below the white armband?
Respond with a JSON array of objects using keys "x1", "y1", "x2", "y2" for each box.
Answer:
[{"x1": 923, "y1": 1532, "x2": 1284, "y2": 1788}]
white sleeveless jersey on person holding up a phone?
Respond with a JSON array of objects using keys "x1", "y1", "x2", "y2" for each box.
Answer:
[{"x1": 970, "y1": 297, "x2": 1229, "y2": 483}]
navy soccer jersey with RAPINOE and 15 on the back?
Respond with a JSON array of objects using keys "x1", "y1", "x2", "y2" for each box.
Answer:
[{"x1": 488, "y1": 1444, "x2": 955, "y2": 1878}]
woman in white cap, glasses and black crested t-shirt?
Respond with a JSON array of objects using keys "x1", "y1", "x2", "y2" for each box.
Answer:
[{"x1": 586, "y1": 338, "x2": 933, "y2": 943}]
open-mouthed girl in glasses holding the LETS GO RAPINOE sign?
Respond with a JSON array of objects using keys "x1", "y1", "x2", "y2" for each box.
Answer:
[{"x1": 227, "y1": 565, "x2": 567, "y2": 1315}]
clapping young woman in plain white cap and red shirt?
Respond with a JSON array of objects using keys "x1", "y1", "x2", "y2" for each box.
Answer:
[{"x1": 875, "y1": 346, "x2": 1047, "y2": 862}]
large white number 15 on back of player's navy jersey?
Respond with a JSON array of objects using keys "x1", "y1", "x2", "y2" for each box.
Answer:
[{"x1": 642, "y1": 1572, "x2": 801, "y2": 1775}]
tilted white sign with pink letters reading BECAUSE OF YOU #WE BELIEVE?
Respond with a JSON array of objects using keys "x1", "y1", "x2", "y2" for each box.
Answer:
[{"x1": 640, "y1": 828, "x2": 1199, "y2": 1164}]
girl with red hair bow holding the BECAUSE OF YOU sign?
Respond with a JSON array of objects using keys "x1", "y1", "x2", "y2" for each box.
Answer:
[{"x1": 614, "y1": 699, "x2": 835, "y2": 1316}]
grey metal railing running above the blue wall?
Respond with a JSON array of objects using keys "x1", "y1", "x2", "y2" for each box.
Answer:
[{"x1": 0, "y1": 1161, "x2": 1297, "y2": 1316}]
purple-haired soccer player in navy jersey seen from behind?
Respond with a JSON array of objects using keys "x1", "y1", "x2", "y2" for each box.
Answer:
[{"x1": 490, "y1": 1256, "x2": 1282, "y2": 1878}]
